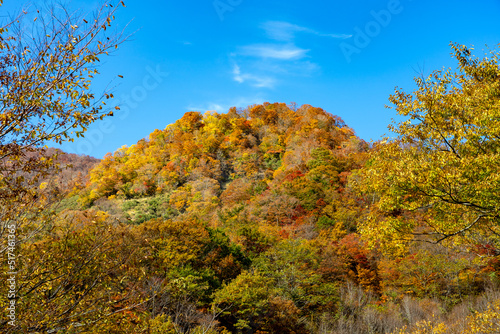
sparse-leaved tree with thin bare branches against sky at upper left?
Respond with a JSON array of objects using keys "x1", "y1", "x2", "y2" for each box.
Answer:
[{"x1": 0, "y1": 1, "x2": 124, "y2": 237}]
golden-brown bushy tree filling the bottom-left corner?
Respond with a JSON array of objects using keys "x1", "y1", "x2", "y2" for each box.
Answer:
[{"x1": 0, "y1": 210, "x2": 144, "y2": 333}]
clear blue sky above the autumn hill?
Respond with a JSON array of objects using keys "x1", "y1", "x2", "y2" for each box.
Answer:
[{"x1": 2, "y1": 0, "x2": 500, "y2": 158}]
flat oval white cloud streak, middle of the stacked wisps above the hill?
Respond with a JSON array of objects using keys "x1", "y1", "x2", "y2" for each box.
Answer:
[{"x1": 239, "y1": 44, "x2": 309, "y2": 60}]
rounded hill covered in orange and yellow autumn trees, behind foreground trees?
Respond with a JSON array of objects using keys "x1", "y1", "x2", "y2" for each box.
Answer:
[{"x1": 79, "y1": 103, "x2": 368, "y2": 228}]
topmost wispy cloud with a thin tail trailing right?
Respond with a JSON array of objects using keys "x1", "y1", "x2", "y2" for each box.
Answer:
[{"x1": 261, "y1": 21, "x2": 352, "y2": 42}]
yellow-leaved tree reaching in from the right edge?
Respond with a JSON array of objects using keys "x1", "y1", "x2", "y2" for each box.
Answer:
[{"x1": 351, "y1": 44, "x2": 500, "y2": 249}]
